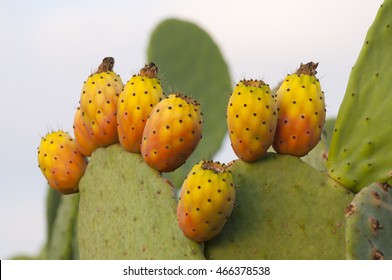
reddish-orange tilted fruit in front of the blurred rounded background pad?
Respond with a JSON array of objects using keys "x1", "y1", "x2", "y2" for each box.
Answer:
[{"x1": 141, "y1": 94, "x2": 203, "y2": 172}]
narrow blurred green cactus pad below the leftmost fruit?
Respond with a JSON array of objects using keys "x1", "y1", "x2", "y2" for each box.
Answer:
[{"x1": 47, "y1": 193, "x2": 79, "y2": 260}]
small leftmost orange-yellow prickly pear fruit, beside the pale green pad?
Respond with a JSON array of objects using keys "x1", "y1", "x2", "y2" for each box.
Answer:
[{"x1": 38, "y1": 130, "x2": 87, "y2": 194}]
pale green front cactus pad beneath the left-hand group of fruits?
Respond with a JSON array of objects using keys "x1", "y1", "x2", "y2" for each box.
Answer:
[{"x1": 78, "y1": 144, "x2": 204, "y2": 259}]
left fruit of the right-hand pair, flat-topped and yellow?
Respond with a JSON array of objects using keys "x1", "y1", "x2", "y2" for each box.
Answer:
[{"x1": 226, "y1": 80, "x2": 278, "y2": 162}]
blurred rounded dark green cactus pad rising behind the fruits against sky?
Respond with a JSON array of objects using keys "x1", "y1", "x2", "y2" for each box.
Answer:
[{"x1": 148, "y1": 19, "x2": 231, "y2": 187}]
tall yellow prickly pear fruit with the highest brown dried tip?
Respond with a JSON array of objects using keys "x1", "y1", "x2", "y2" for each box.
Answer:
[{"x1": 75, "y1": 57, "x2": 124, "y2": 156}]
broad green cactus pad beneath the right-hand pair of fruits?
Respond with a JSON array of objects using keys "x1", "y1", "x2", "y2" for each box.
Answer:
[{"x1": 205, "y1": 153, "x2": 353, "y2": 259}]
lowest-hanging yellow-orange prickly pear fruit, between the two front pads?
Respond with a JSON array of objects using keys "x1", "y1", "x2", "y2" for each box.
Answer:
[{"x1": 177, "y1": 161, "x2": 236, "y2": 242}]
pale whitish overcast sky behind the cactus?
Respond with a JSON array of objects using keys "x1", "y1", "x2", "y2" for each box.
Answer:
[{"x1": 0, "y1": 0, "x2": 383, "y2": 259}]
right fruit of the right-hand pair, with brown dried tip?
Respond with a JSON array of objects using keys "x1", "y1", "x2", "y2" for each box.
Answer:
[{"x1": 273, "y1": 62, "x2": 325, "y2": 157}]
